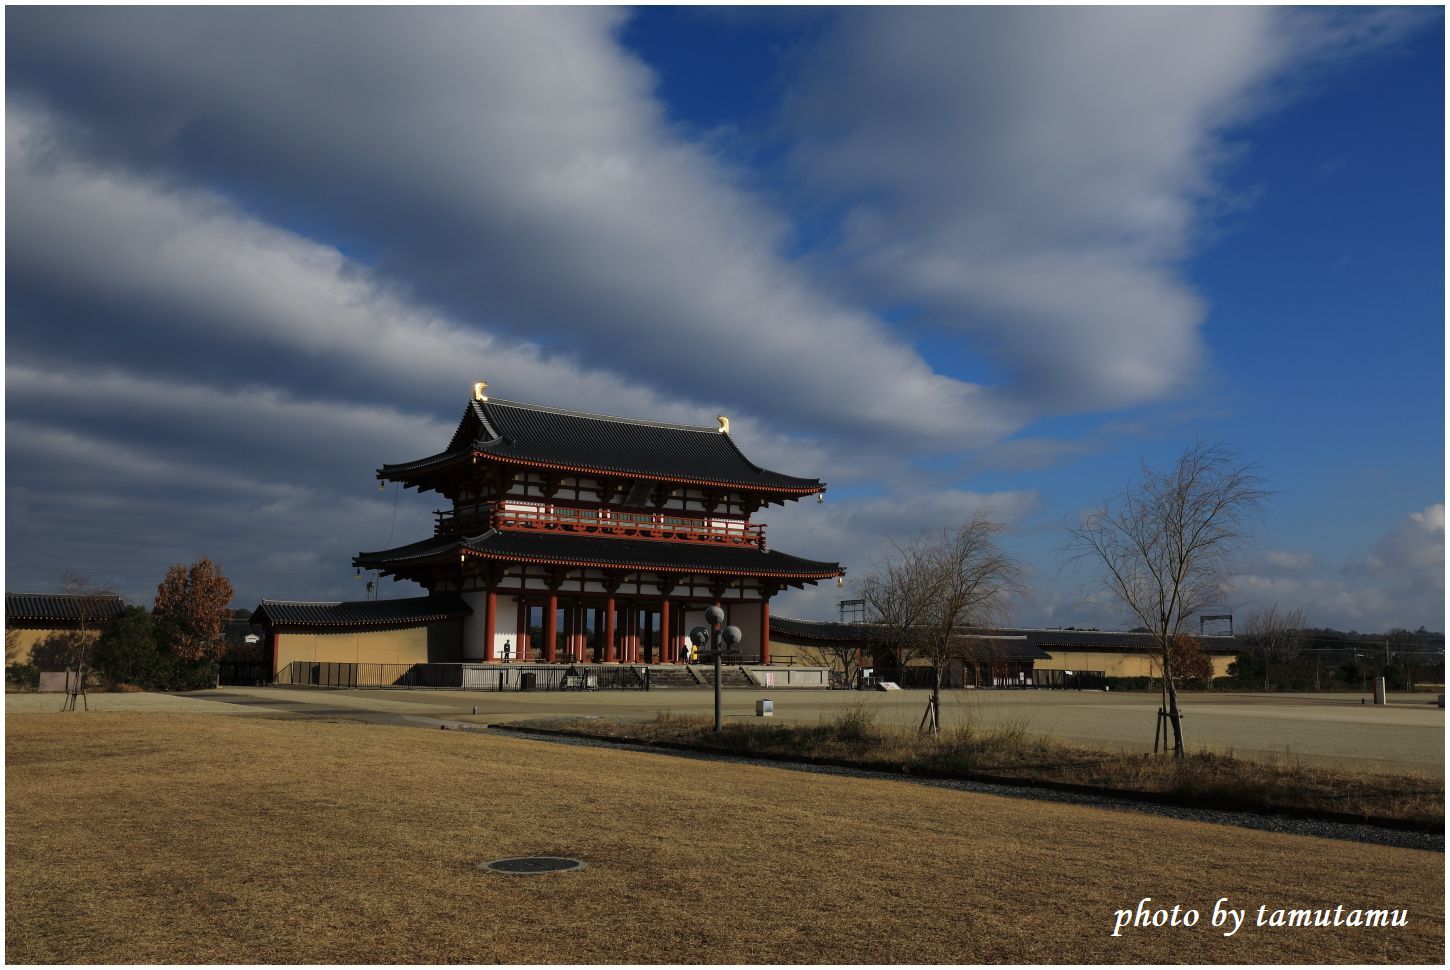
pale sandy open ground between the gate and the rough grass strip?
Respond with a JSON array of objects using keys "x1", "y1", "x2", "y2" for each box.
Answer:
[{"x1": 36, "y1": 687, "x2": 1446, "y2": 777}]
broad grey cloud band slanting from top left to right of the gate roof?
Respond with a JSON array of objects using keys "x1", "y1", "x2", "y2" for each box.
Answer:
[{"x1": 9, "y1": 9, "x2": 1011, "y2": 441}]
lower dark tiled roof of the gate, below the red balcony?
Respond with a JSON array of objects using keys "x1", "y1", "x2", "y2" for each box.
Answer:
[{"x1": 354, "y1": 529, "x2": 844, "y2": 579}]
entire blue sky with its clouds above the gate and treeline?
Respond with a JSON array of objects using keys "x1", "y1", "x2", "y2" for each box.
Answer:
[{"x1": 6, "y1": 7, "x2": 1444, "y2": 631}]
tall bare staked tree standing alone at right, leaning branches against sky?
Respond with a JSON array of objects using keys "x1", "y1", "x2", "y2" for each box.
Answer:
[{"x1": 1069, "y1": 442, "x2": 1269, "y2": 757}]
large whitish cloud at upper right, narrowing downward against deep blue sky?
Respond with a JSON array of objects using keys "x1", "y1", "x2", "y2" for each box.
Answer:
[{"x1": 786, "y1": 7, "x2": 1393, "y2": 415}]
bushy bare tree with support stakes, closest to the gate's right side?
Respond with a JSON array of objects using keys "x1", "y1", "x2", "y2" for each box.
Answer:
[{"x1": 861, "y1": 510, "x2": 1022, "y2": 735}]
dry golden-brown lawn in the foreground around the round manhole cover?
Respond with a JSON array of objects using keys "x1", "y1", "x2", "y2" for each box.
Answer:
[{"x1": 6, "y1": 713, "x2": 1444, "y2": 963}]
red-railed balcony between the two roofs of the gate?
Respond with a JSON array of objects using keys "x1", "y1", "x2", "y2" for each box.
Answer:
[{"x1": 434, "y1": 506, "x2": 766, "y2": 550}]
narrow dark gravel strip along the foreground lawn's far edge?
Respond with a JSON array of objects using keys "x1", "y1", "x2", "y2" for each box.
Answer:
[{"x1": 484, "y1": 722, "x2": 1446, "y2": 853}]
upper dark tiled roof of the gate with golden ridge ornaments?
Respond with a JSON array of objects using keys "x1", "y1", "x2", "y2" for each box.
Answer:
[{"x1": 378, "y1": 399, "x2": 825, "y2": 494}]
